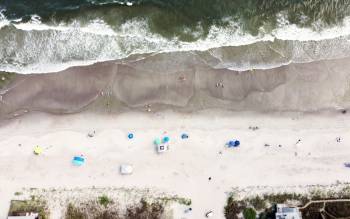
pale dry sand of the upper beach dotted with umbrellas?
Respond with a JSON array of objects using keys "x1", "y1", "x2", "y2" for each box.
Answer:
[{"x1": 0, "y1": 110, "x2": 350, "y2": 219}]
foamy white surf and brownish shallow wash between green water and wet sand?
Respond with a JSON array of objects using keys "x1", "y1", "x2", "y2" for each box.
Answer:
[{"x1": 0, "y1": 14, "x2": 350, "y2": 74}]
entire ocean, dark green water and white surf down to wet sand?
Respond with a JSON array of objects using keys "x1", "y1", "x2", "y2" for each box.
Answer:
[{"x1": 0, "y1": 0, "x2": 350, "y2": 74}]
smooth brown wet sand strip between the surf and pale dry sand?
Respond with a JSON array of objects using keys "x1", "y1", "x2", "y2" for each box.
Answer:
[{"x1": 0, "y1": 53, "x2": 350, "y2": 118}]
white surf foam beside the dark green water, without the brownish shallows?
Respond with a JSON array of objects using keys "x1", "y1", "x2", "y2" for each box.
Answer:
[{"x1": 0, "y1": 13, "x2": 350, "y2": 74}]
